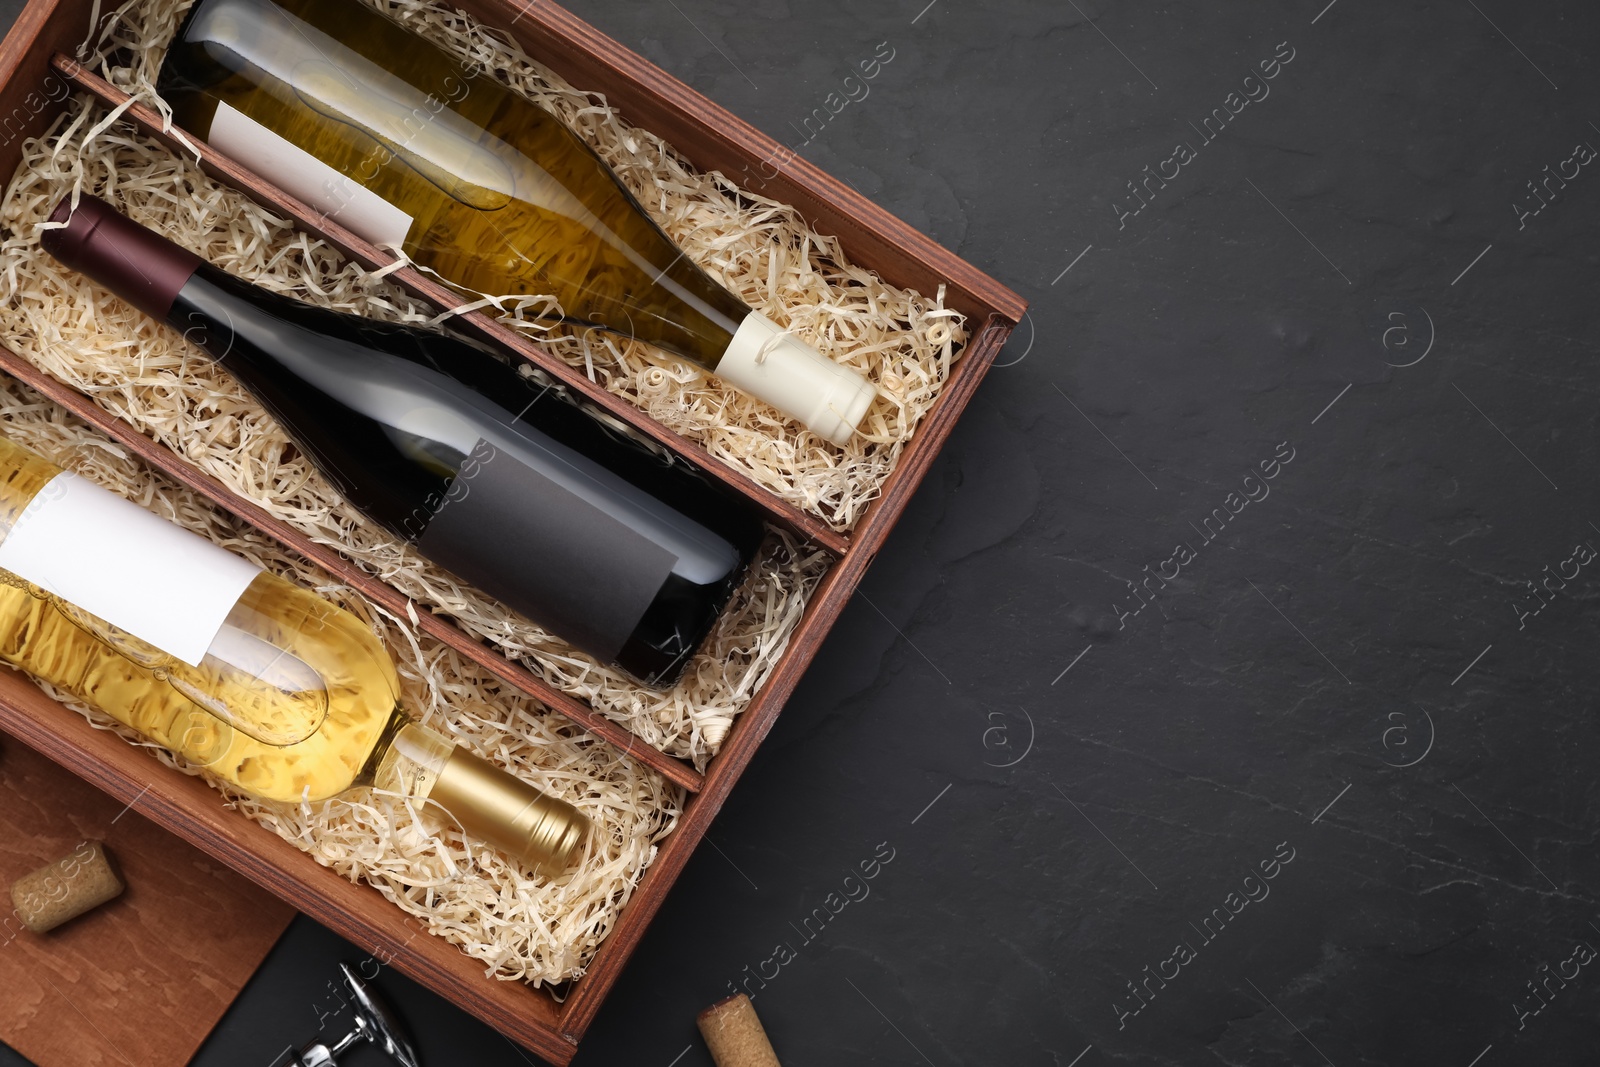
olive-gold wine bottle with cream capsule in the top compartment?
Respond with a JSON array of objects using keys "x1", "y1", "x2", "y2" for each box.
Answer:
[{"x1": 157, "y1": 0, "x2": 877, "y2": 445}]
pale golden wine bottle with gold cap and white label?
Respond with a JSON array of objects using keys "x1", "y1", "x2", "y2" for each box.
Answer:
[{"x1": 0, "y1": 438, "x2": 587, "y2": 875}]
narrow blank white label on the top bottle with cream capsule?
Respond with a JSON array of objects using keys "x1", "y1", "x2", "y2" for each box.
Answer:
[{"x1": 206, "y1": 101, "x2": 413, "y2": 248}]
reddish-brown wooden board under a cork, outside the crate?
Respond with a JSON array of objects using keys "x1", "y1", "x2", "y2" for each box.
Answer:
[{"x1": 0, "y1": 734, "x2": 294, "y2": 1067}]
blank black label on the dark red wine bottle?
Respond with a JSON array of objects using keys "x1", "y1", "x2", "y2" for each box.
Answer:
[{"x1": 418, "y1": 440, "x2": 677, "y2": 662}]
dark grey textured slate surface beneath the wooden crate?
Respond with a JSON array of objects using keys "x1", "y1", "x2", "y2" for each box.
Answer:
[{"x1": 3, "y1": 0, "x2": 1600, "y2": 1067}]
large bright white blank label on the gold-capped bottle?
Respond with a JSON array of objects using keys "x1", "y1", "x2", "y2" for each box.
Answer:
[{"x1": 0, "y1": 472, "x2": 261, "y2": 667}]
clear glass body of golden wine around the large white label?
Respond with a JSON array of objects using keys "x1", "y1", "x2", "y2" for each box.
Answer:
[{"x1": 0, "y1": 440, "x2": 398, "y2": 801}]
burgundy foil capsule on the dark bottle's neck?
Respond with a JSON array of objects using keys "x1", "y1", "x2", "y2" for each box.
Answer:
[{"x1": 40, "y1": 195, "x2": 205, "y2": 322}]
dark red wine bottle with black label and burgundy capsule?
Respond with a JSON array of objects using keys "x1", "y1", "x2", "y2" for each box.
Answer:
[{"x1": 42, "y1": 197, "x2": 762, "y2": 685}]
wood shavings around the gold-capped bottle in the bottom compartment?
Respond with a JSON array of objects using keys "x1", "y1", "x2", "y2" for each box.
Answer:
[{"x1": 0, "y1": 376, "x2": 683, "y2": 985}]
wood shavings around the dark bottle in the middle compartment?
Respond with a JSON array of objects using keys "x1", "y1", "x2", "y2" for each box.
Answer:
[{"x1": 0, "y1": 98, "x2": 830, "y2": 769}]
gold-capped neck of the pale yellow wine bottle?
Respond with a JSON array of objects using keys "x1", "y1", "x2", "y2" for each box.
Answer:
[{"x1": 366, "y1": 709, "x2": 589, "y2": 878}]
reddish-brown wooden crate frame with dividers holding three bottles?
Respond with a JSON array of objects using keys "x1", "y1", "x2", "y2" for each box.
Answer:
[{"x1": 0, "y1": 0, "x2": 1026, "y2": 1064}]
